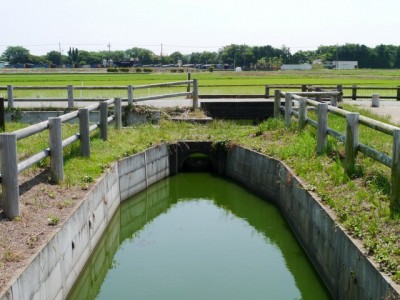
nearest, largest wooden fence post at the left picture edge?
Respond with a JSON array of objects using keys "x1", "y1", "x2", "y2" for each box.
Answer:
[{"x1": 0, "y1": 133, "x2": 19, "y2": 219}]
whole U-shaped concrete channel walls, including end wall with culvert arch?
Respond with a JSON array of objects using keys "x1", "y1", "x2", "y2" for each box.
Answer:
[{"x1": 0, "y1": 142, "x2": 400, "y2": 299}]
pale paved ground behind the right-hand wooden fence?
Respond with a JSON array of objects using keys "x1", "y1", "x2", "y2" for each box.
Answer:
[{"x1": 343, "y1": 100, "x2": 400, "y2": 126}]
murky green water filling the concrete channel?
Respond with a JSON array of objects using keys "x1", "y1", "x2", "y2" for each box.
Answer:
[{"x1": 69, "y1": 173, "x2": 330, "y2": 300}]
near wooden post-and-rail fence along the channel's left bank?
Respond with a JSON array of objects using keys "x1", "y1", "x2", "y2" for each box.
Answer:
[{"x1": 0, "y1": 98, "x2": 122, "y2": 219}]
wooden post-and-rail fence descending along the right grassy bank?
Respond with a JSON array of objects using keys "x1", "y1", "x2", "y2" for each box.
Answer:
[{"x1": 274, "y1": 90, "x2": 400, "y2": 208}]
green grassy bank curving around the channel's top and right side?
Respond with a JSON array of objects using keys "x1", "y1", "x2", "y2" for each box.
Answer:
[{"x1": 3, "y1": 109, "x2": 400, "y2": 282}]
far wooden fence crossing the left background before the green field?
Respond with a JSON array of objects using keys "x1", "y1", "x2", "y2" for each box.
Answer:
[{"x1": 0, "y1": 75, "x2": 198, "y2": 109}]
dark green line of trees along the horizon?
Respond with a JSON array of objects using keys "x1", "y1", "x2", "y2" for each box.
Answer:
[{"x1": 0, "y1": 44, "x2": 400, "y2": 69}]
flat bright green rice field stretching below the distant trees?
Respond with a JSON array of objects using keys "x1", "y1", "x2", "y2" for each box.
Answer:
[{"x1": 0, "y1": 69, "x2": 400, "y2": 98}]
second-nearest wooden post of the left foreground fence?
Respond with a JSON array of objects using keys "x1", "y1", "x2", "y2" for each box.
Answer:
[{"x1": 49, "y1": 117, "x2": 64, "y2": 182}]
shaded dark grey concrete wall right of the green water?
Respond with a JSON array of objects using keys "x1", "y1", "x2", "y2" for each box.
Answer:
[{"x1": 227, "y1": 147, "x2": 400, "y2": 299}]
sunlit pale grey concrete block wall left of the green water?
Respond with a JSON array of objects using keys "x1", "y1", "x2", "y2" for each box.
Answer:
[{"x1": 0, "y1": 145, "x2": 169, "y2": 300}]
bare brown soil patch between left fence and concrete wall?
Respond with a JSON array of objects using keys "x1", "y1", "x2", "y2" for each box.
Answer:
[{"x1": 0, "y1": 170, "x2": 89, "y2": 295}]
